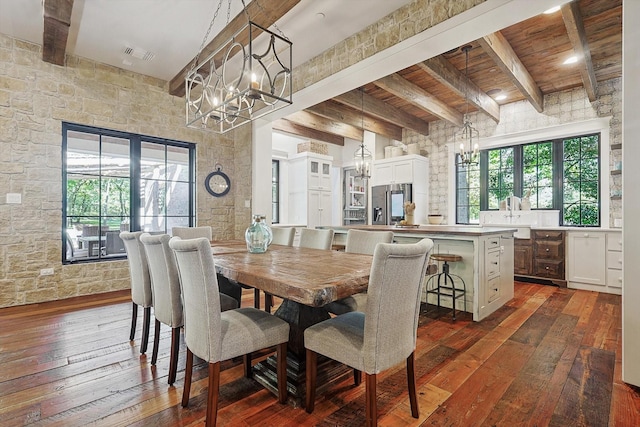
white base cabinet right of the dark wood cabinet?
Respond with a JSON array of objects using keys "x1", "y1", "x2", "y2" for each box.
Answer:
[{"x1": 567, "y1": 230, "x2": 607, "y2": 292}]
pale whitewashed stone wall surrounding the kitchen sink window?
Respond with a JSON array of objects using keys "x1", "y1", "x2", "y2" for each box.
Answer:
[{"x1": 402, "y1": 79, "x2": 622, "y2": 225}]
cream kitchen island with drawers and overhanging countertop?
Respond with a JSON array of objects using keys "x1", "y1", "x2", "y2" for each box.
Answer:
[{"x1": 317, "y1": 225, "x2": 516, "y2": 321}]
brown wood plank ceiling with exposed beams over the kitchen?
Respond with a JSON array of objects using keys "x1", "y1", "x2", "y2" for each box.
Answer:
[{"x1": 274, "y1": 0, "x2": 622, "y2": 145}]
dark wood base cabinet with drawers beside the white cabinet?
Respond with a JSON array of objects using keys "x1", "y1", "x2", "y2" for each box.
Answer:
[{"x1": 513, "y1": 230, "x2": 567, "y2": 287}]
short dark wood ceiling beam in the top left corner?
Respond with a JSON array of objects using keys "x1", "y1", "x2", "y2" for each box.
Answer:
[{"x1": 42, "y1": 0, "x2": 73, "y2": 65}]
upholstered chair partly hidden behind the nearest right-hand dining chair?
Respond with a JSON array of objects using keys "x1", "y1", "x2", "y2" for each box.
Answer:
[{"x1": 324, "y1": 229, "x2": 393, "y2": 314}]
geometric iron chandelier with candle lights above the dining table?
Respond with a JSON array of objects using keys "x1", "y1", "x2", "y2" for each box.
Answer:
[{"x1": 185, "y1": 0, "x2": 293, "y2": 133}]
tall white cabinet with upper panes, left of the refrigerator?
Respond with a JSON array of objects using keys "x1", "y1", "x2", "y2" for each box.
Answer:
[{"x1": 289, "y1": 153, "x2": 333, "y2": 228}]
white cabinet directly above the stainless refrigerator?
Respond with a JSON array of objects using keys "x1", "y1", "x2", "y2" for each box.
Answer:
[{"x1": 371, "y1": 154, "x2": 429, "y2": 186}]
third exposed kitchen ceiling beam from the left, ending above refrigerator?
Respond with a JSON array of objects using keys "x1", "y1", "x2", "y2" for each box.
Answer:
[{"x1": 305, "y1": 100, "x2": 402, "y2": 141}]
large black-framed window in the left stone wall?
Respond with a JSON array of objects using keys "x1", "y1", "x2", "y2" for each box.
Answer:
[{"x1": 62, "y1": 123, "x2": 195, "y2": 263}]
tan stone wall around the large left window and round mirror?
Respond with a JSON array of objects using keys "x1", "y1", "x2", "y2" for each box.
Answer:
[{"x1": 0, "y1": 34, "x2": 251, "y2": 307}]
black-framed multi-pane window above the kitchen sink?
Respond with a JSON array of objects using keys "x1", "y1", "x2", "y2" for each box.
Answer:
[{"x1": 456, "y1": 134, "x2": 601, "y2": 227}]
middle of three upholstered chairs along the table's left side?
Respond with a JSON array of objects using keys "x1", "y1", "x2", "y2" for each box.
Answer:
[{"x1": 140, "y1": 233, "x2": 238, "y2": 384}]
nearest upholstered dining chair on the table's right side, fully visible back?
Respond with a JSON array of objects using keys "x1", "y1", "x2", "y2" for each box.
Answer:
[{"x1": 304, "y1": 239, "x2": 433, "y2": 425}]
